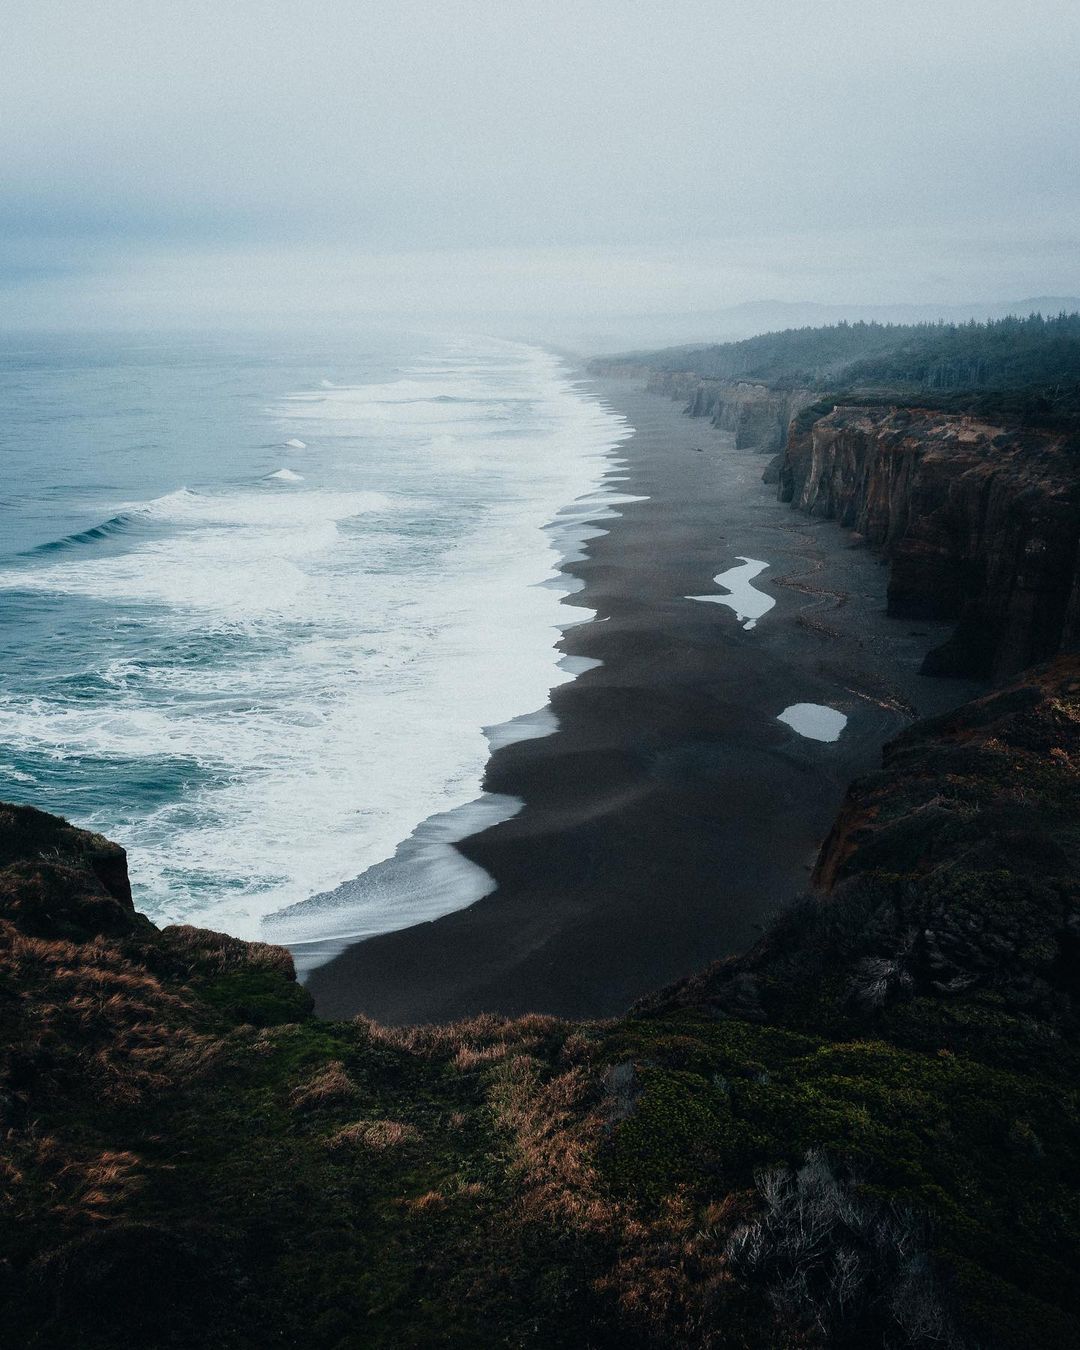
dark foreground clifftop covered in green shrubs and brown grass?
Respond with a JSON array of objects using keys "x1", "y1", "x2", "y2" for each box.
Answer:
[{"x1": 0, "y1": 660, "x2": 1080, "y2": 1350}]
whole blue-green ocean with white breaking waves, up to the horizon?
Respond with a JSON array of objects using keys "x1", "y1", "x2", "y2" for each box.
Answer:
[{"x1": 0, "y1": 332, "x2": 628, "y2": 950}]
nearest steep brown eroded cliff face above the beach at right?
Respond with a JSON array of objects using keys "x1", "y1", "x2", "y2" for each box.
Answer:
[{"x1": 779, "y1": 406, "x2": 1080, "y2": 679}]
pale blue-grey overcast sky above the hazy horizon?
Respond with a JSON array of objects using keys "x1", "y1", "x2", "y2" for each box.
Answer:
[{"x1": 0, "y1": 0, "x2": 1080, "y2": 323}]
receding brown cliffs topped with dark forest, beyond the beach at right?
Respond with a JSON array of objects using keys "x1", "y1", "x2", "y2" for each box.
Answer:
[{"x1": 591, "y1": 313, "x2": 1080, "y2": 680}]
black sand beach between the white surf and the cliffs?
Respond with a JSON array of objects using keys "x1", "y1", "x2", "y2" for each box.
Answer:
[{"x1": 308, "y1": 381, "x2": 975, "y2": 1023}]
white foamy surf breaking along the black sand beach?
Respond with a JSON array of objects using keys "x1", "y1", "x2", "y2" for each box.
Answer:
[{"x1": 0, "y1": 343, "x2": 633, "y2": 938}]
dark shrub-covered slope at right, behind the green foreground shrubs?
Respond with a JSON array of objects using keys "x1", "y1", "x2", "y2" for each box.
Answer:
[{"x1": 649, "y1": 656, "x2": 1080, "y2": 1042}]
